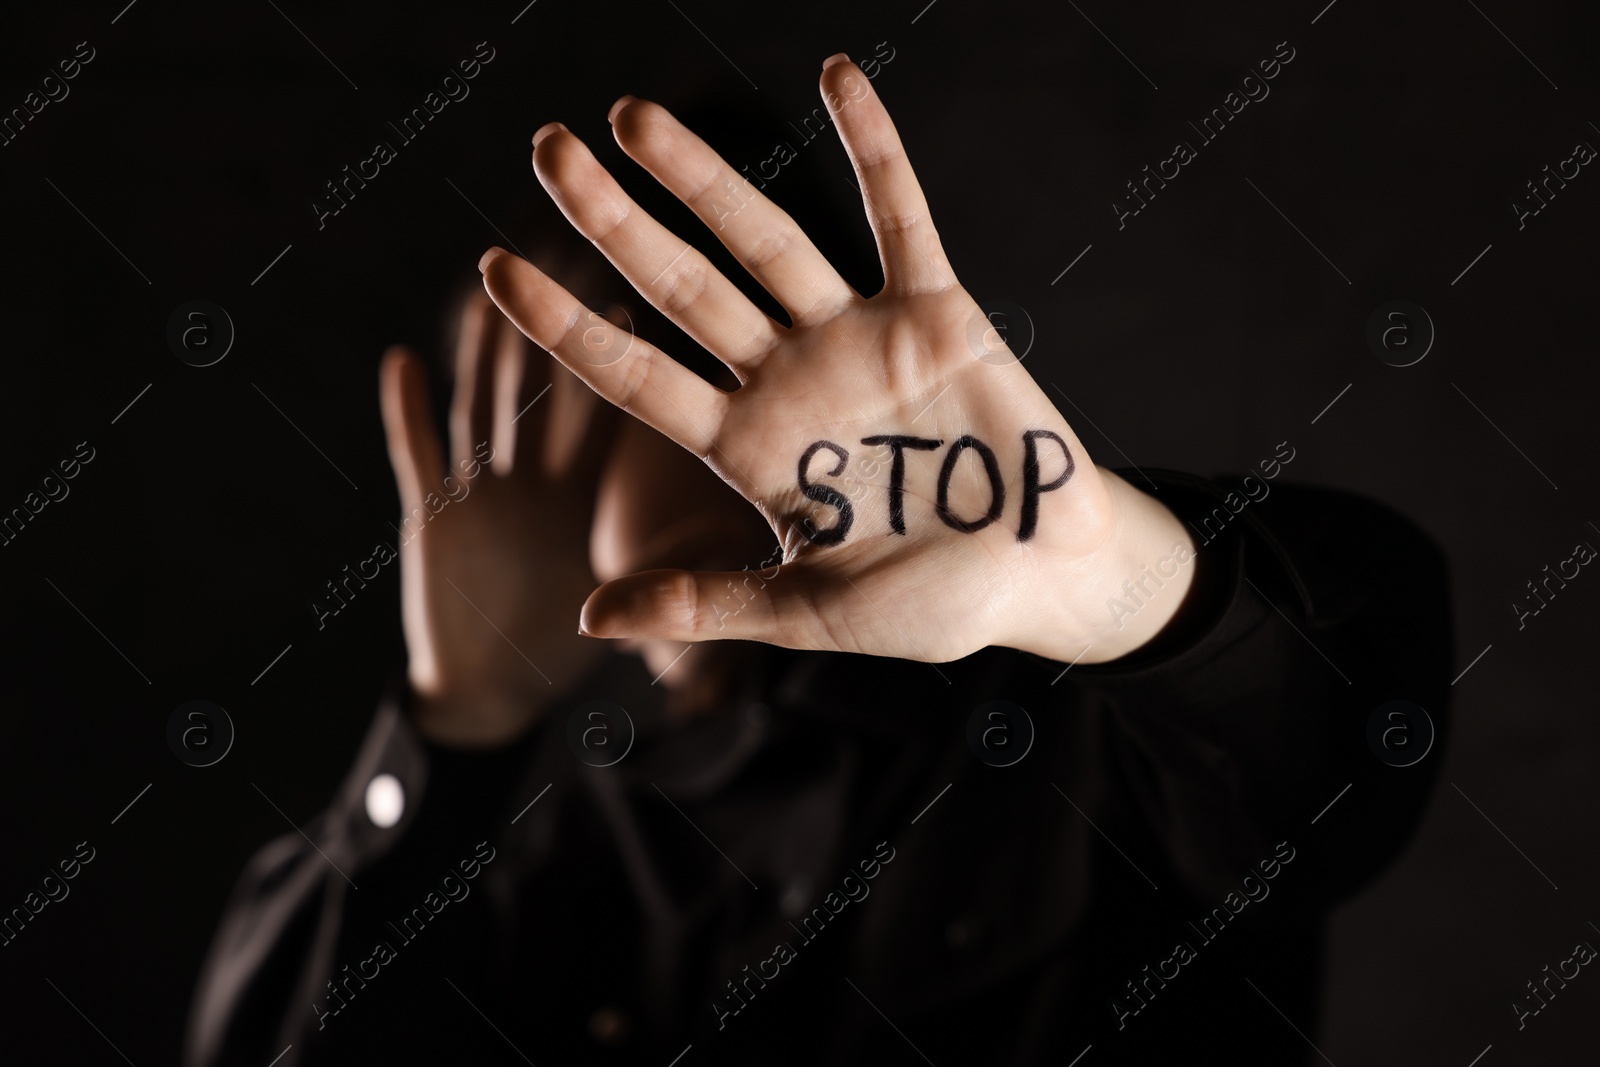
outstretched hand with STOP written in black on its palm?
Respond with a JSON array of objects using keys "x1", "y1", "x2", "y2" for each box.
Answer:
[{"x1": 480, "y1": 56, "x2": 1189, "y2": 662}]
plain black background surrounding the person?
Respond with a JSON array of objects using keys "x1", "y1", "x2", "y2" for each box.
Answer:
[{"x1": 0, "y1": 0, "x2": 1600, "y2": 1067}]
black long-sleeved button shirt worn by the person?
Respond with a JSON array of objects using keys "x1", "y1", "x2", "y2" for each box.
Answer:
[{"x1": 189, "y1": 472, "x2": 1451, "y2": 1067}]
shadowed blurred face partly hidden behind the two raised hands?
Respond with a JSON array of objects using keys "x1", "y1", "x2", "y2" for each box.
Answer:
[{"x1": 589, "y1": 416, "x2": 778, "y2": 686}]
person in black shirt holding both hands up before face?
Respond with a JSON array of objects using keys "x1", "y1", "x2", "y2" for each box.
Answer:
[{"x1": 190, "y1": 56, "x2": 1450, "y2": 1064}]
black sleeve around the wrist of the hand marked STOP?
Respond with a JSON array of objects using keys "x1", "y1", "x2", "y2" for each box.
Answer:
[{"x1": 1072, "y1": 472, "x2": 1453, "y2": 910}]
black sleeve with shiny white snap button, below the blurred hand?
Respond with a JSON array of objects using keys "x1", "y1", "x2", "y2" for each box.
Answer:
[{"x1": 186, "y1": 678, "x2": 538, "y2": 1067}]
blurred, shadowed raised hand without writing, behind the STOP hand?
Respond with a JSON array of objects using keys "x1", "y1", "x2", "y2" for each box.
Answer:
[{"x1": 379, "y1": 294, "x2": 614, "y2": 745}]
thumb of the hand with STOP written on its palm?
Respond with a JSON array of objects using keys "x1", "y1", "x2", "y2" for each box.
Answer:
[{"x1": 578, "y1": 565, "x2": 832, "y2": 648}]
